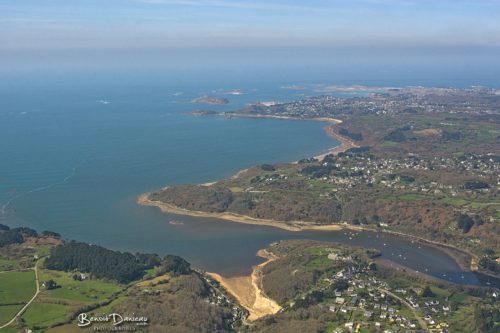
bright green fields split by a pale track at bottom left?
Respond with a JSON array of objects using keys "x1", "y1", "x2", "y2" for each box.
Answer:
[{"x1": 0, "y1": 247, "x2": 129, "y2": 333}]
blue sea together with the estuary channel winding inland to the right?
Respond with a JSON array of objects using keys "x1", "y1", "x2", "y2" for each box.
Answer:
[{"x1": 0, "y1": 67, "x2": 498, "y2": 285}]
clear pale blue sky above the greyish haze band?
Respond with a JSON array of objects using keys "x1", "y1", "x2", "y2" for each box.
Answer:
[{"x1": 0, "y1": 0, "x2": 500, "y2": 68}]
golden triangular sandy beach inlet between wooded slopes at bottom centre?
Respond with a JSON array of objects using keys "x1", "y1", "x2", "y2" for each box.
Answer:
[{"x1": 207, "y1": 250, "x2": 281, "y2": 321}]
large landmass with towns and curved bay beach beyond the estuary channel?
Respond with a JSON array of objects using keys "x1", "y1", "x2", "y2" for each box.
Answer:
[{"x1": 139, "y1": 87, "x2": 500, "y2": 275}]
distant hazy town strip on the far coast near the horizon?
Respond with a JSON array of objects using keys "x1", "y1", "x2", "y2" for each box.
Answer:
[{"x1": 246, "y1": 87, "x2": 498, "y2": 119}]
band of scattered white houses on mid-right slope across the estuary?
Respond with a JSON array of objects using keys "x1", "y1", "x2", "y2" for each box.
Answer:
[{"x1": 308, "y1": 154, "x2": 500, "y2": 196}]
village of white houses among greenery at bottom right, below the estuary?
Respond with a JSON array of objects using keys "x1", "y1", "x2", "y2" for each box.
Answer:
[{"x1": 316, "y1": 265, "x2": 453, "y2": 333}]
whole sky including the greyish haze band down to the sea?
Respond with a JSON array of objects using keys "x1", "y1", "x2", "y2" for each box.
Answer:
[{"x1": 0, "y1": 0, "x2": 500, "y2": 72}]
